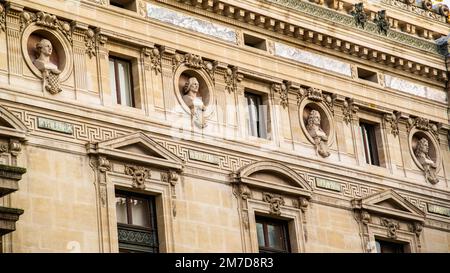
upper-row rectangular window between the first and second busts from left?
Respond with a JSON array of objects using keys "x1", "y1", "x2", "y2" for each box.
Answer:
[{"x1": 109, "y1": 57, "x2": 135, "y2": 107}]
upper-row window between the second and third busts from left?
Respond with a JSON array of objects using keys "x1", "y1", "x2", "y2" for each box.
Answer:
[{"x1": 245, "y1": 92, "x2": 267, "y2": 138}]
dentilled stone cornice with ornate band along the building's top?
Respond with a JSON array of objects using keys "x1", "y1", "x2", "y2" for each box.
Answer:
[{"x1": 155, "y1": 0, "x2": 447, "y2": 82}]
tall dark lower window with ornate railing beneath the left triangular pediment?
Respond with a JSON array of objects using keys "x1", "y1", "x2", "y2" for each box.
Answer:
[{"x1": 116, "y1": 191, "x2": 159, "y2": 253}]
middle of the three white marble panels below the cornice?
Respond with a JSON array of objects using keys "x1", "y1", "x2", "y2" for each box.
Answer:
[{"x1": 274, "y1": 42, "x2": 352, "y2": 77}]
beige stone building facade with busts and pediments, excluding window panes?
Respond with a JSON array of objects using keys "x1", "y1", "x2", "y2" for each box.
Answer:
[{"x1": 0, "y1": 0, "x2": 450, "y2": 252}]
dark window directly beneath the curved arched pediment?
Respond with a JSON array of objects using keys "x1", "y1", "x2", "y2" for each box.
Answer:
[{"x1": 256, "y1": 217, "x2": 290, "y2": 253}]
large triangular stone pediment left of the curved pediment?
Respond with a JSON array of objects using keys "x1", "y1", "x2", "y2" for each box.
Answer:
[{"x1": 87, "y1": 132, "x2": 183, "y2": 169}]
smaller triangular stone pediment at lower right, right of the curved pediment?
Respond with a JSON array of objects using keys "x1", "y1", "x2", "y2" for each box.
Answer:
[{"x1": 352, "y1": 189, "x2": 425, "y2": 221}]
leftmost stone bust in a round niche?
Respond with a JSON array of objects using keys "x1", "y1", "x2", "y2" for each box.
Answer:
[{"x1": 33, "y1": 39, "x2": 62, "y2": 94}]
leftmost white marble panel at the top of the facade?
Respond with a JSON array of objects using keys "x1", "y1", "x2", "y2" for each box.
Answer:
[{"x1": 147, "y1": 3, "x2": 237, "y2": 44}]
